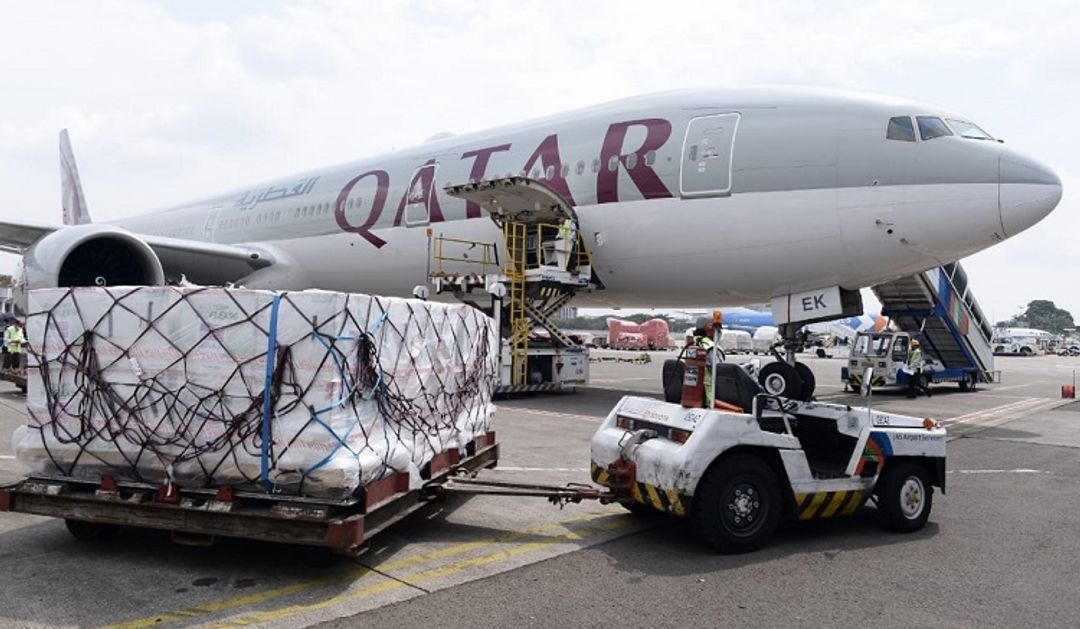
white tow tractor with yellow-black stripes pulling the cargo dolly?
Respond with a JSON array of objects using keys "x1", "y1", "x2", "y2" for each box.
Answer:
[{"x1": 592, "y1": 363, "x2": 945, "y2": 552}]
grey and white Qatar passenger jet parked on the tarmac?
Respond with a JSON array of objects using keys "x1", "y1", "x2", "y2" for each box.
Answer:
[{"x1": 0, "y1": 88, "x2": 1062, "y2": 354}]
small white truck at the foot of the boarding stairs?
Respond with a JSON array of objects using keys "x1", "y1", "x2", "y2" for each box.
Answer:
[{"x1": 840, "y1": 332, "x2": 981, "y2": 391}]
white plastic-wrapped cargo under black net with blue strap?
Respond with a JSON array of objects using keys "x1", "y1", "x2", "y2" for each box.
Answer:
[{"x1": 15, "y1": 286, "x2": 498, "y2": 498}]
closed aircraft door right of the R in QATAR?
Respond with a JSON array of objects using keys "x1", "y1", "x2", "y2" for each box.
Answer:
[{"x1": 679, "y1": 113, "x2": 739, "y2": 197}]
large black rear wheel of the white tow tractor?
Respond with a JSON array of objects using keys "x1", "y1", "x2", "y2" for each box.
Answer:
[{"x1": 690, "y1": 454, "x2": 781, "y2": 553}]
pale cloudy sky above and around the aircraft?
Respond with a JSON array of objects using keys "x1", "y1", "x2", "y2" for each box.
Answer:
[{"x1": 0, "y1": 0, "x2": 1080, "y2": 321}]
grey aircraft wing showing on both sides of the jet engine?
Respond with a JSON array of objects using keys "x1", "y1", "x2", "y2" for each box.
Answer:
[{"x1": 0, "y1": 220, "x2": 274, "y2": 284}]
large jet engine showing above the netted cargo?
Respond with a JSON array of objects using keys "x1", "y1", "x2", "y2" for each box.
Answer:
[{"x1": 15, "y1": 224, "x2": 165, "y2": 310}]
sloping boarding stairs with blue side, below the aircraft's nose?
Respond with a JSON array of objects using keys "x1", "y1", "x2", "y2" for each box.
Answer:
[{"x1": 873, "y1": 263, "x2": 1000, "y2": 383}]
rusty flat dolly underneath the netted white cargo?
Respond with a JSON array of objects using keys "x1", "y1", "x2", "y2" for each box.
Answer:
[{"x1": 0, "y1": 432, "x2": 499, "y2": 554}]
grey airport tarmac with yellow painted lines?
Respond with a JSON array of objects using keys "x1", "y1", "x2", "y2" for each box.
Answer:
[{"x1": 0, "y1": 352, "x2": 1080, "y2": 628}]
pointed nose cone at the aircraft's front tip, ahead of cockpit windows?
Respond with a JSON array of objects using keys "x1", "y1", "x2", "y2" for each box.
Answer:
[{"x1": 998, "y1": 149, "x2": 1062, "y2": 236}]
